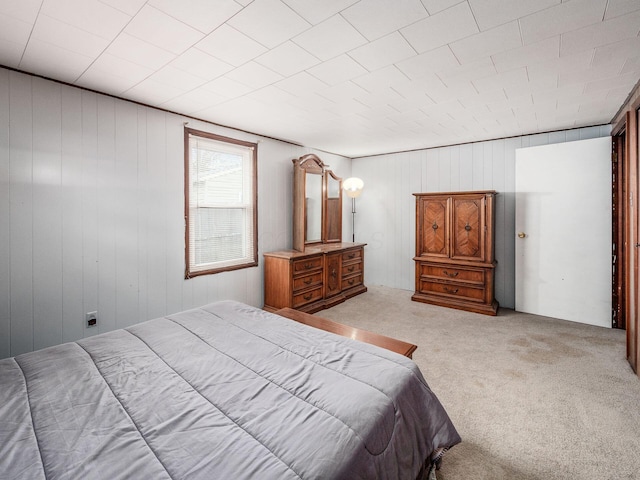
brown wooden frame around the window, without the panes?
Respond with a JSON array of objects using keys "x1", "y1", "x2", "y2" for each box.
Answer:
[{"x1": 184, "y1": 127, "x2": 258, "y2": 279}]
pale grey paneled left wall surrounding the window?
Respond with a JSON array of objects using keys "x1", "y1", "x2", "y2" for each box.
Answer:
[{"x1": 0, "y1": 68, "x2": 351, "y2": 358}]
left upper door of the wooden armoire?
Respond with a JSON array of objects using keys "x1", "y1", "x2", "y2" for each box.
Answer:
[{"x1": 416, "y1": 196, "x2": 449, "y2": 258}]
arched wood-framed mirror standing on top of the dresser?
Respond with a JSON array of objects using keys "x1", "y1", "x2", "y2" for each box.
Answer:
[{"x1": 293, "y1": 154, "x2": 342, "y2": 252}]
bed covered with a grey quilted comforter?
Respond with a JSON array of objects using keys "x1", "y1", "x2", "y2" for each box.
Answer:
[{"x1": 0, "y1": 301, "x2": 460, "y2": 480}]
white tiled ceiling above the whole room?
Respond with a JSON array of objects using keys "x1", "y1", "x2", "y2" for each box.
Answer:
[{"x1": 0, "y1": 0, "x2": 640, "y2": 157}]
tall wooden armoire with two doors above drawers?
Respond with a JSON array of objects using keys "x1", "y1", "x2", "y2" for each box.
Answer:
[{"x1": 411, "y1": 190, "x2": 498, "y2": 315}]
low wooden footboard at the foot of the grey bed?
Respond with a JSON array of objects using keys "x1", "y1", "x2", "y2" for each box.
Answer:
[{"x1": 275, "y1": 308, "x2": 418, "y2": 358}]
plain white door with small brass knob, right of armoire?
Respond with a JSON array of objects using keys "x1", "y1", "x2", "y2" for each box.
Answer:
[{"x1": 515, "y1": 137, "x2": 612, "y2": 327}]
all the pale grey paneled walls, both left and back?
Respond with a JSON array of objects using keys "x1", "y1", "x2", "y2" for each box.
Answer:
[{"x1": 0, "y1": 68, "x2": 609, "y2": 358}]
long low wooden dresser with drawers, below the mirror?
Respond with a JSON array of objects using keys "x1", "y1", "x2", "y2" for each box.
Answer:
[{"x1": 264, "y1": 243, "x2": 367, "y2": 313}]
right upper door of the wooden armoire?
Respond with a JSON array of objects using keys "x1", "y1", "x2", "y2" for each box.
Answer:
[{"x1": 451, "y1": 195, "x2": 486, "y2": 262}]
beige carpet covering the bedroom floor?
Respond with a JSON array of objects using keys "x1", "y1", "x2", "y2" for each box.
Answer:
[{"x1": 316, "y1": 286, "x2": 640, "y2": 480}]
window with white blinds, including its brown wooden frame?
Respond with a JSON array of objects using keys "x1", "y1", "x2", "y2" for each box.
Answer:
[{"x1": 185, "y1": 128, "x2": 258, "y2": 278}]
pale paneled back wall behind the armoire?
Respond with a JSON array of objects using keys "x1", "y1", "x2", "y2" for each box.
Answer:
[{"x1": 352, "y1": 125, "x2": 611, "y2": 308}]
